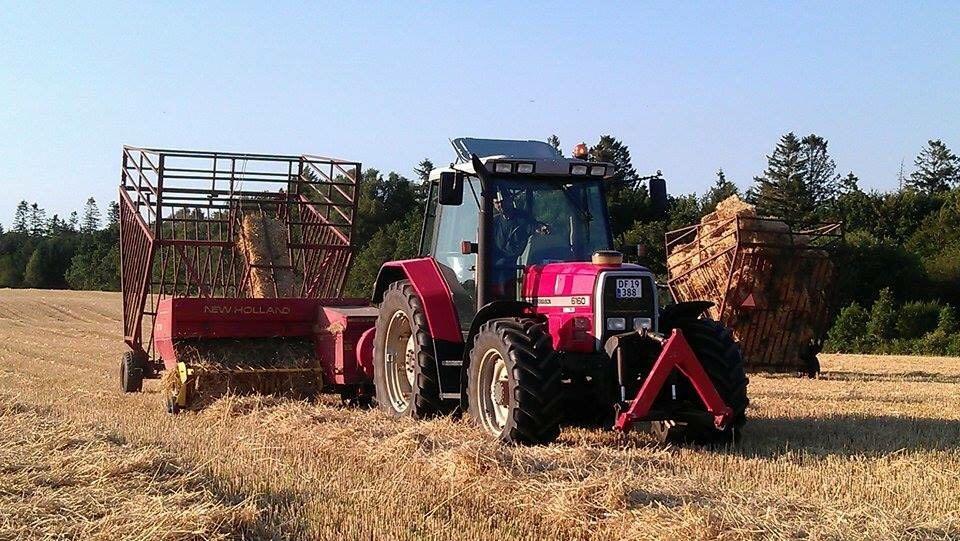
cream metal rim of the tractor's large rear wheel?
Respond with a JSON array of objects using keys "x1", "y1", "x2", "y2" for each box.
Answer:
[{"x1": 383, "y1": 310, "x2": 417, "y2": 413}]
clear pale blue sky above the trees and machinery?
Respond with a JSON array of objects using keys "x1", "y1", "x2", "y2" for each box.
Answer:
[{"x1": 0, "y1": 2, "x2": 960, "y2": 225}]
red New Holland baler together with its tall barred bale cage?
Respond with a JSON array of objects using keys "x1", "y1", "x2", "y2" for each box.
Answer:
[{"x1": 119, "y1": 147, "x2": 376, "y2": 412}]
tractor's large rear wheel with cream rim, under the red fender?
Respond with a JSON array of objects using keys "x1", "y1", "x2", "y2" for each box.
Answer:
[{"x1": 373, "y1": 280, "x2": 443, "y2": 419}]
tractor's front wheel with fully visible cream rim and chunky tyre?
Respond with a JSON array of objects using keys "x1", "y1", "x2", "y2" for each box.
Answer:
[{"x1": 467, "y1": 318, "x2": 563, "y2": 444}]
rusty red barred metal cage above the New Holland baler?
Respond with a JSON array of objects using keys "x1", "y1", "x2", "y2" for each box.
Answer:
[{"x1": 119, "y1": 146, "x2": 361, "y2": 365}]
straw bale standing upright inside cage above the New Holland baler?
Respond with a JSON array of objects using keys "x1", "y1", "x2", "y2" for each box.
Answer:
[{"x1": 237, "y1": 211, "x2": 301, "y2": 298}]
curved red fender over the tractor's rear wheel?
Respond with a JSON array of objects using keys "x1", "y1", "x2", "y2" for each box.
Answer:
[{"x1": 381, "y1": 257, "x2": 463, "y2": 343}]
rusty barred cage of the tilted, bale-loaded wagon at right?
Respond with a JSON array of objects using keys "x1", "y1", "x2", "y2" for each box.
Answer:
[{"x1": 665, "y1": 216, "x2": 843, "y2": 371}]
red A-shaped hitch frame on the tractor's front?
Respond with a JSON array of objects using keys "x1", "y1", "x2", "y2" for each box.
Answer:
[{"x1": 614, "y1": 329, "x2": 733, "y2": 432}]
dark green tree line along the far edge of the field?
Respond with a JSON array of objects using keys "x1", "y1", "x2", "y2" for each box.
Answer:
[{"x1": 0, "y1": 133, "x2": 960, "y2": 349}]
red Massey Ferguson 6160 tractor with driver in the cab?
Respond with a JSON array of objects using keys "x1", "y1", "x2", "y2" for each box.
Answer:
[{"x1": 368, "y1": 138, "x2": 748, "y2": 444}]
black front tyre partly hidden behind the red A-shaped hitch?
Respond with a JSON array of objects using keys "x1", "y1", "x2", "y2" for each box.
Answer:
[{"x1": 651, "y1": 319, "x2": 749, "y2": 445}]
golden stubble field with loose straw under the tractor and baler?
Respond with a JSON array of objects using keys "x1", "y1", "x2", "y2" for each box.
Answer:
[{"x1": 0, "y1": 290, "x2": 960, "y2": 540}]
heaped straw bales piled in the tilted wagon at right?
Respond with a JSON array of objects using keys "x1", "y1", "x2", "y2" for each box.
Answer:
[{"x1": 667, "y1": 196, "x2": 834, "y2": 372}]
